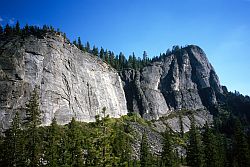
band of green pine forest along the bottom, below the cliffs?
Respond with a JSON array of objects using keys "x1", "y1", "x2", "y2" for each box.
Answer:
[{"x1": 0, "y1": 104, "x2": 249, "y2": 167}]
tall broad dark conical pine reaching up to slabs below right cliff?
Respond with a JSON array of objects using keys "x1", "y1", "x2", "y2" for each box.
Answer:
[{"x1": 187, "y1": 116, "x2": 203, "y2": 167}]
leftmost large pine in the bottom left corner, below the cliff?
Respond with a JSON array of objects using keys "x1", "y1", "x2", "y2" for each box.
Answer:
[{"x1": 2, "y1": 112, "x2": 24, "y2": 167}]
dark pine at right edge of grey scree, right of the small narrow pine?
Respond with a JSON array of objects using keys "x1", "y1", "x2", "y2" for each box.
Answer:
[{"x1": 161, "y1": 130, "x2": 176, "y2": 167}]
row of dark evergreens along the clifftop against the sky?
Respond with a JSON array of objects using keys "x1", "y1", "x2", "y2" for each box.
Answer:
[{"x1": 0, "y1": 21, "x2": 186, "y2": 71}]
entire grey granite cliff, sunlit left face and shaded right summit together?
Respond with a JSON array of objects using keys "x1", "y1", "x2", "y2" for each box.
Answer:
[{"x1": 0, "y1": 33, "x2": 223, "y2": 131}]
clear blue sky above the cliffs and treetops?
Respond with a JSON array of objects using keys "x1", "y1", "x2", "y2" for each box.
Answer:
[{"x1": 0, "y1": 0, "x2": 250, "y2": 95}]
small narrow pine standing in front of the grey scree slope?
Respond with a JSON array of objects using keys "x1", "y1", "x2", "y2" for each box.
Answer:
[{"x1": 140, "y1": 133, "x2": 151, "y2": 167}]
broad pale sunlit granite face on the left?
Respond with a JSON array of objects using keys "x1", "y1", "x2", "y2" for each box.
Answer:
[{"x1": 0, "y1": 34, "x2": 127, "y2": 129}]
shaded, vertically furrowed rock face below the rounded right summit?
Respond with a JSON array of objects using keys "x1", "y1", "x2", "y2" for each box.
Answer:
[{"x1": 120, "y1": 45, "x2": 223, "y2": 120}]
